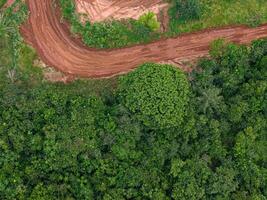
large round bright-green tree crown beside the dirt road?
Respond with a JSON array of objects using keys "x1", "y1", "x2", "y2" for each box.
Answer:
[{"x1": 119, "y1": 64, "x2": 189, "y2": 129}]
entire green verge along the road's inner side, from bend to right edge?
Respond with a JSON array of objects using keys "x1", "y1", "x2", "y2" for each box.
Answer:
[{"x1": 60, "y1": 0, "x2": 267, "y2": 48}]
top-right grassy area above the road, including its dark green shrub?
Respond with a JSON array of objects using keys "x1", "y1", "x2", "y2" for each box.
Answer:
[{"x1": 169, "y1": 0, "x2": 267, "y2": 35}]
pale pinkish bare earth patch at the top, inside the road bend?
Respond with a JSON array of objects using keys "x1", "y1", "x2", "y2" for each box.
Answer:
[{"x1": 75, "y1": 0, "x2": 168, "y2": 22}]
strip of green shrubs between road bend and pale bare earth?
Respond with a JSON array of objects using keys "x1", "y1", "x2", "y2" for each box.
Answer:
[{"x1": 60, "y1": 0, "x2": 160, "y2": 48}]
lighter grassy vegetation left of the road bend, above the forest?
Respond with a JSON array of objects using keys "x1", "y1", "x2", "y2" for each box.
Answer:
[{"x1": 0, "y1": 0, "x2": 38, "y2": 84}]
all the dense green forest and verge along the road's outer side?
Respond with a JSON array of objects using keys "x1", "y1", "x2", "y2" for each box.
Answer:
[{"x1": 0, "y1": 0, "x2": 267, "y2": 200}]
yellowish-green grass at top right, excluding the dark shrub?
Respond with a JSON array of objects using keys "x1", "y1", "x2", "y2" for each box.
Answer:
[{"x1": 170, "y1": 0, "x2": 267, "y2": 35}]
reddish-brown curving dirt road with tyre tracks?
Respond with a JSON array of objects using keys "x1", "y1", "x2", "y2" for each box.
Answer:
[{"x1": 22, "y1": 0, "x2": 267, "y2": 77}]
